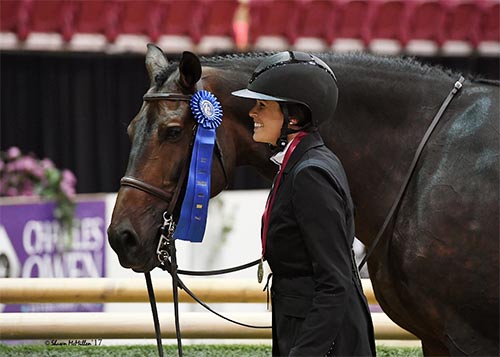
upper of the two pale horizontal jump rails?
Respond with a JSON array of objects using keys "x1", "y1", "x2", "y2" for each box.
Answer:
[{"x1": 0, "y1": 278, "x2": 377, "y2": 304}]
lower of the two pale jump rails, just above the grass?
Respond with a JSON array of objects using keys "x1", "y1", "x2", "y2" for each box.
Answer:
[{"x1": 0, "y1": 312, "x2": 417, "y2": 340}]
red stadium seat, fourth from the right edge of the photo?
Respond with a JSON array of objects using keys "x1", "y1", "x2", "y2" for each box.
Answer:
[{"x1": 369, "y1": 0, "x2": 408, "y2": 54}]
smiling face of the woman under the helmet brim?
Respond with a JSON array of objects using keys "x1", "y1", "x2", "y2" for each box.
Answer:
[{"x1": 248, "y1": 100, "x2": 283, "y2": 145}]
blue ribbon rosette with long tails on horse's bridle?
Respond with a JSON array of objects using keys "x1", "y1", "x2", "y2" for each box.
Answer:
[{"x1": 174, "y1": 90, "x2": 222, "y2": 242}]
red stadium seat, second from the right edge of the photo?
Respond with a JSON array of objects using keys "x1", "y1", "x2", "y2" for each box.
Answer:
[{"x1": 442, "y1": 0, "x2": 482, "y2": 55}]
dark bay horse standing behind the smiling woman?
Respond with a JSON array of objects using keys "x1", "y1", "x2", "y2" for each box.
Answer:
[{"x1": 108, "y1": 45, "x2": 499, "y2": 356}]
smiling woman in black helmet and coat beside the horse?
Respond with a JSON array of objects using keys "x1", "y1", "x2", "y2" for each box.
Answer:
[{"x1": 233, "y1": 52, "x2": 376, "y2": 356}]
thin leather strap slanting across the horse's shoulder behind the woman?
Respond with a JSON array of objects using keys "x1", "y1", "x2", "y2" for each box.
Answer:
[{"x1": 358, "y1": 76, "x2": 465, "y2": 270}]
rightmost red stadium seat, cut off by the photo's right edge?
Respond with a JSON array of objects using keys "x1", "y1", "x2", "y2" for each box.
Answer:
[{"x1": 478, "y1": 1, "x2": 500, "y2": 56}]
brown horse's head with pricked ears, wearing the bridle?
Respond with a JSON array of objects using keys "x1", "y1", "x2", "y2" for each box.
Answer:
[{"x1": 108, "y1": 45, "x2": 251, "y2": 271}]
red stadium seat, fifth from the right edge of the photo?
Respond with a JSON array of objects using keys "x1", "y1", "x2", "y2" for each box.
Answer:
[{"x1": 332, "y1": 0, "x2": 375, "y2": 52}]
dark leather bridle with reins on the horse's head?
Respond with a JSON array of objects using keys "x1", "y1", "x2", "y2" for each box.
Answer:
[{"x1": 120, "y1": 85, "x2": 271, "y2": 357}]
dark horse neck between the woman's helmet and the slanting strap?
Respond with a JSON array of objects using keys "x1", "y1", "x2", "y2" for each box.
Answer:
[{"x1": 322, "y1": 62, "x2": 452, "y2": 245}]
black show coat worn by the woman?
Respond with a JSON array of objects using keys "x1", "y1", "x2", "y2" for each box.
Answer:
[{"x1": 265, "y1": 132, "x2": 376, "y2": 356}]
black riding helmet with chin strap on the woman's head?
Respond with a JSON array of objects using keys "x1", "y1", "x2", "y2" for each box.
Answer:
[{"x1": 232, "y1": 51, "x2": 338, "y2": 149}]
